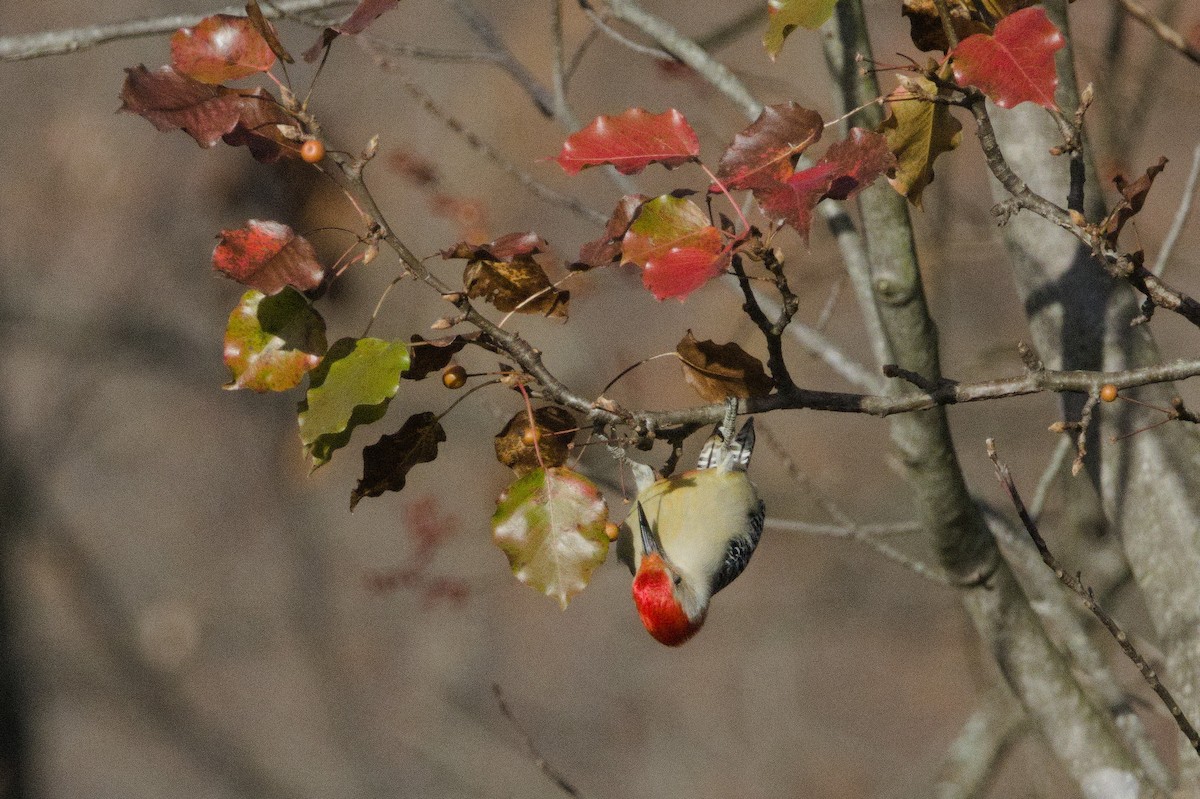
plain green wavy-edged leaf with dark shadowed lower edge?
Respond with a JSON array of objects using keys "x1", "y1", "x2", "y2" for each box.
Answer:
[{"x1": 300, "y1": 338, "x2": 409, "y2": 469}]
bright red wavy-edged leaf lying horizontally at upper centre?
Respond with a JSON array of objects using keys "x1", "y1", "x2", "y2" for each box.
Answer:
[{"x1": 556, "y1": 108, "x2": 700, "y2": 175}]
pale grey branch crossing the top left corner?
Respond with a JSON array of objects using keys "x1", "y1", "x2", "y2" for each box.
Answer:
[{"x1": 0, "y1": 0, "x2": 353, "y2": 61}]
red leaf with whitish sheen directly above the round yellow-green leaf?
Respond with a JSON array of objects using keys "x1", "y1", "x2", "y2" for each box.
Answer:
[{"x1": 212, "y1": 220, "x2": 325, "y2": 294}]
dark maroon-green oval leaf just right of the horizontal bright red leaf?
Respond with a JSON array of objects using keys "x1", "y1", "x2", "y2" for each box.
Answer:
[{"x1": 716, "y1": 103, "x2": 823, "y2": 190}]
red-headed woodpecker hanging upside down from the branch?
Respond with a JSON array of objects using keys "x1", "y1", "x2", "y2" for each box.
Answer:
[{"x1": 618, "y1": 415, "x2": 766, "y2": 647}]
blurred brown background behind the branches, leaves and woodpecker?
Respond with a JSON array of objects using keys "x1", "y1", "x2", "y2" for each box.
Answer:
[{"x1": 0, "y1": 0, "x2": 1200, "y2": 799}]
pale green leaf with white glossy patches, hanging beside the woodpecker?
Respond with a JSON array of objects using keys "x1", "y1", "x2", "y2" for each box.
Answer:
[{"x1": 492, "y1": 468, "x2": 608, "y2": 611}]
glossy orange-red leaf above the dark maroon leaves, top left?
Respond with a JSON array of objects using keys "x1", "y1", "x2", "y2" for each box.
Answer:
[{"x1": 170, "y1": 14, "x2": 275, "y2": 84}]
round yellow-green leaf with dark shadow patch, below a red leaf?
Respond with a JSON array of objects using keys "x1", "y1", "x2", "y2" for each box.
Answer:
[{"x1": 224, "y1": 288, "x2": 326, "y2": 391}]
